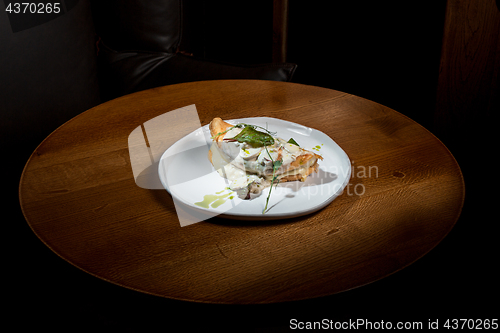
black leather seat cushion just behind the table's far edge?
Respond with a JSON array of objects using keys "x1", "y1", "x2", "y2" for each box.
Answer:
[{"x1": 99, "y1": 42, "x2": 296, "y2": 100}]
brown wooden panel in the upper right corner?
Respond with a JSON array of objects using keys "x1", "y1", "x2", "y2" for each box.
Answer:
[{"x1": 434, "y1": 0, "x2": 500, "y2": 139}]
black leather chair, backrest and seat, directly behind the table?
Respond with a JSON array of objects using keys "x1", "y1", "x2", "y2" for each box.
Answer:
[{"x1": 92, "y1": 0, "x2": 296, "y2": 100}]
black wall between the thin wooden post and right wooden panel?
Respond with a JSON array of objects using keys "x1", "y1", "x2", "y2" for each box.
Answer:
[{"x1": 288, "y1": 0, "x2": 445, "y2": 130}]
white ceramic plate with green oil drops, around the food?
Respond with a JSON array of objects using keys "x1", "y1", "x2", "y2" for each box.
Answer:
[{"x1": 158, "y1": 117, "x2": 351, "y2": 219}]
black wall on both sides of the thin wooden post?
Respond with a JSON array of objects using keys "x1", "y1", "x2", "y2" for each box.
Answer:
[{"x1": 184, "y1": 0, "x2": 446, "y2": 131}]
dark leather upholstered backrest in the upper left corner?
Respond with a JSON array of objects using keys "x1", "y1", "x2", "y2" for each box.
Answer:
[{"x1": 0, "y1": 0, "x2": 100, "y2": 150}]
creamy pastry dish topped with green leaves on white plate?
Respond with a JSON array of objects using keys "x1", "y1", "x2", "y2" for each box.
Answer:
[{"x1": 208, "y1": 118, "x2": 323, "y2": 212}]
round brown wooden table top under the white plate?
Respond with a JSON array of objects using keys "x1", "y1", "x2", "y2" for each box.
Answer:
[{"x1": 19, "y1": 80, "x2": 464, "y2": 304}]
